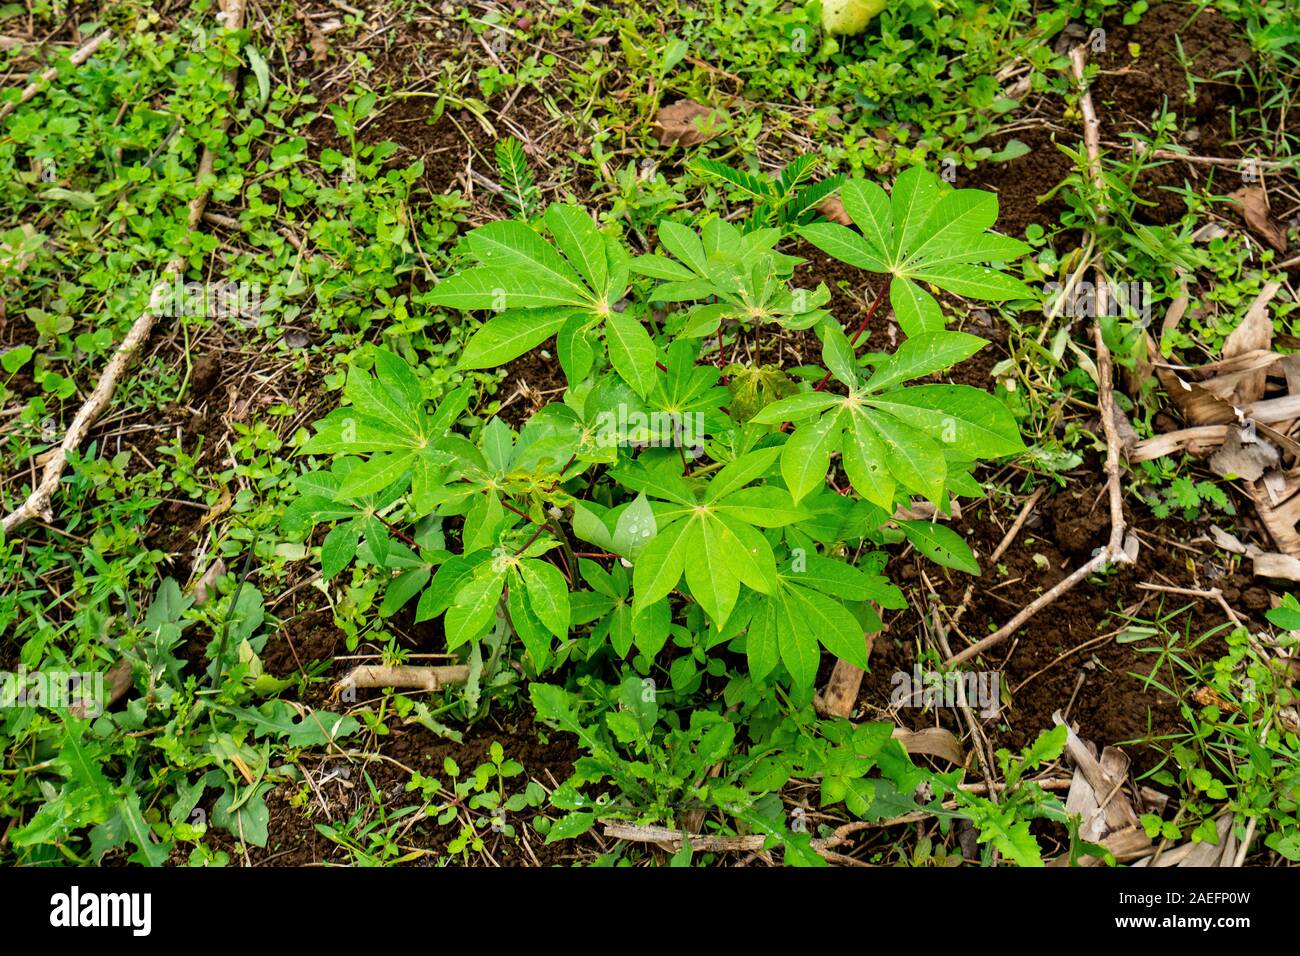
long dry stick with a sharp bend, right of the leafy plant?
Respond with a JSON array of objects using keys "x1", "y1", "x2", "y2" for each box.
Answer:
[{"x1": 944, "y1": 46, "x2": 1132, "y2": 667}]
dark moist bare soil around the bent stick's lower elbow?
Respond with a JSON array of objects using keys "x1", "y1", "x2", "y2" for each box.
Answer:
[{"x1": 858, "y1": 489, "x2": 1268, "y2": 773}]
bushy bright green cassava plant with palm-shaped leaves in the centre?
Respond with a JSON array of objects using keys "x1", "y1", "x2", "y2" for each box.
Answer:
[{"x1": 290, "y1": 169, "x2": 1031, "y2": 700}]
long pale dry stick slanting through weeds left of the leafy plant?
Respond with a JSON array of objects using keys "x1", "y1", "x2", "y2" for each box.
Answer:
[{"x1": 0, "y1": 0, "x2": 244, "y2": 535}]
